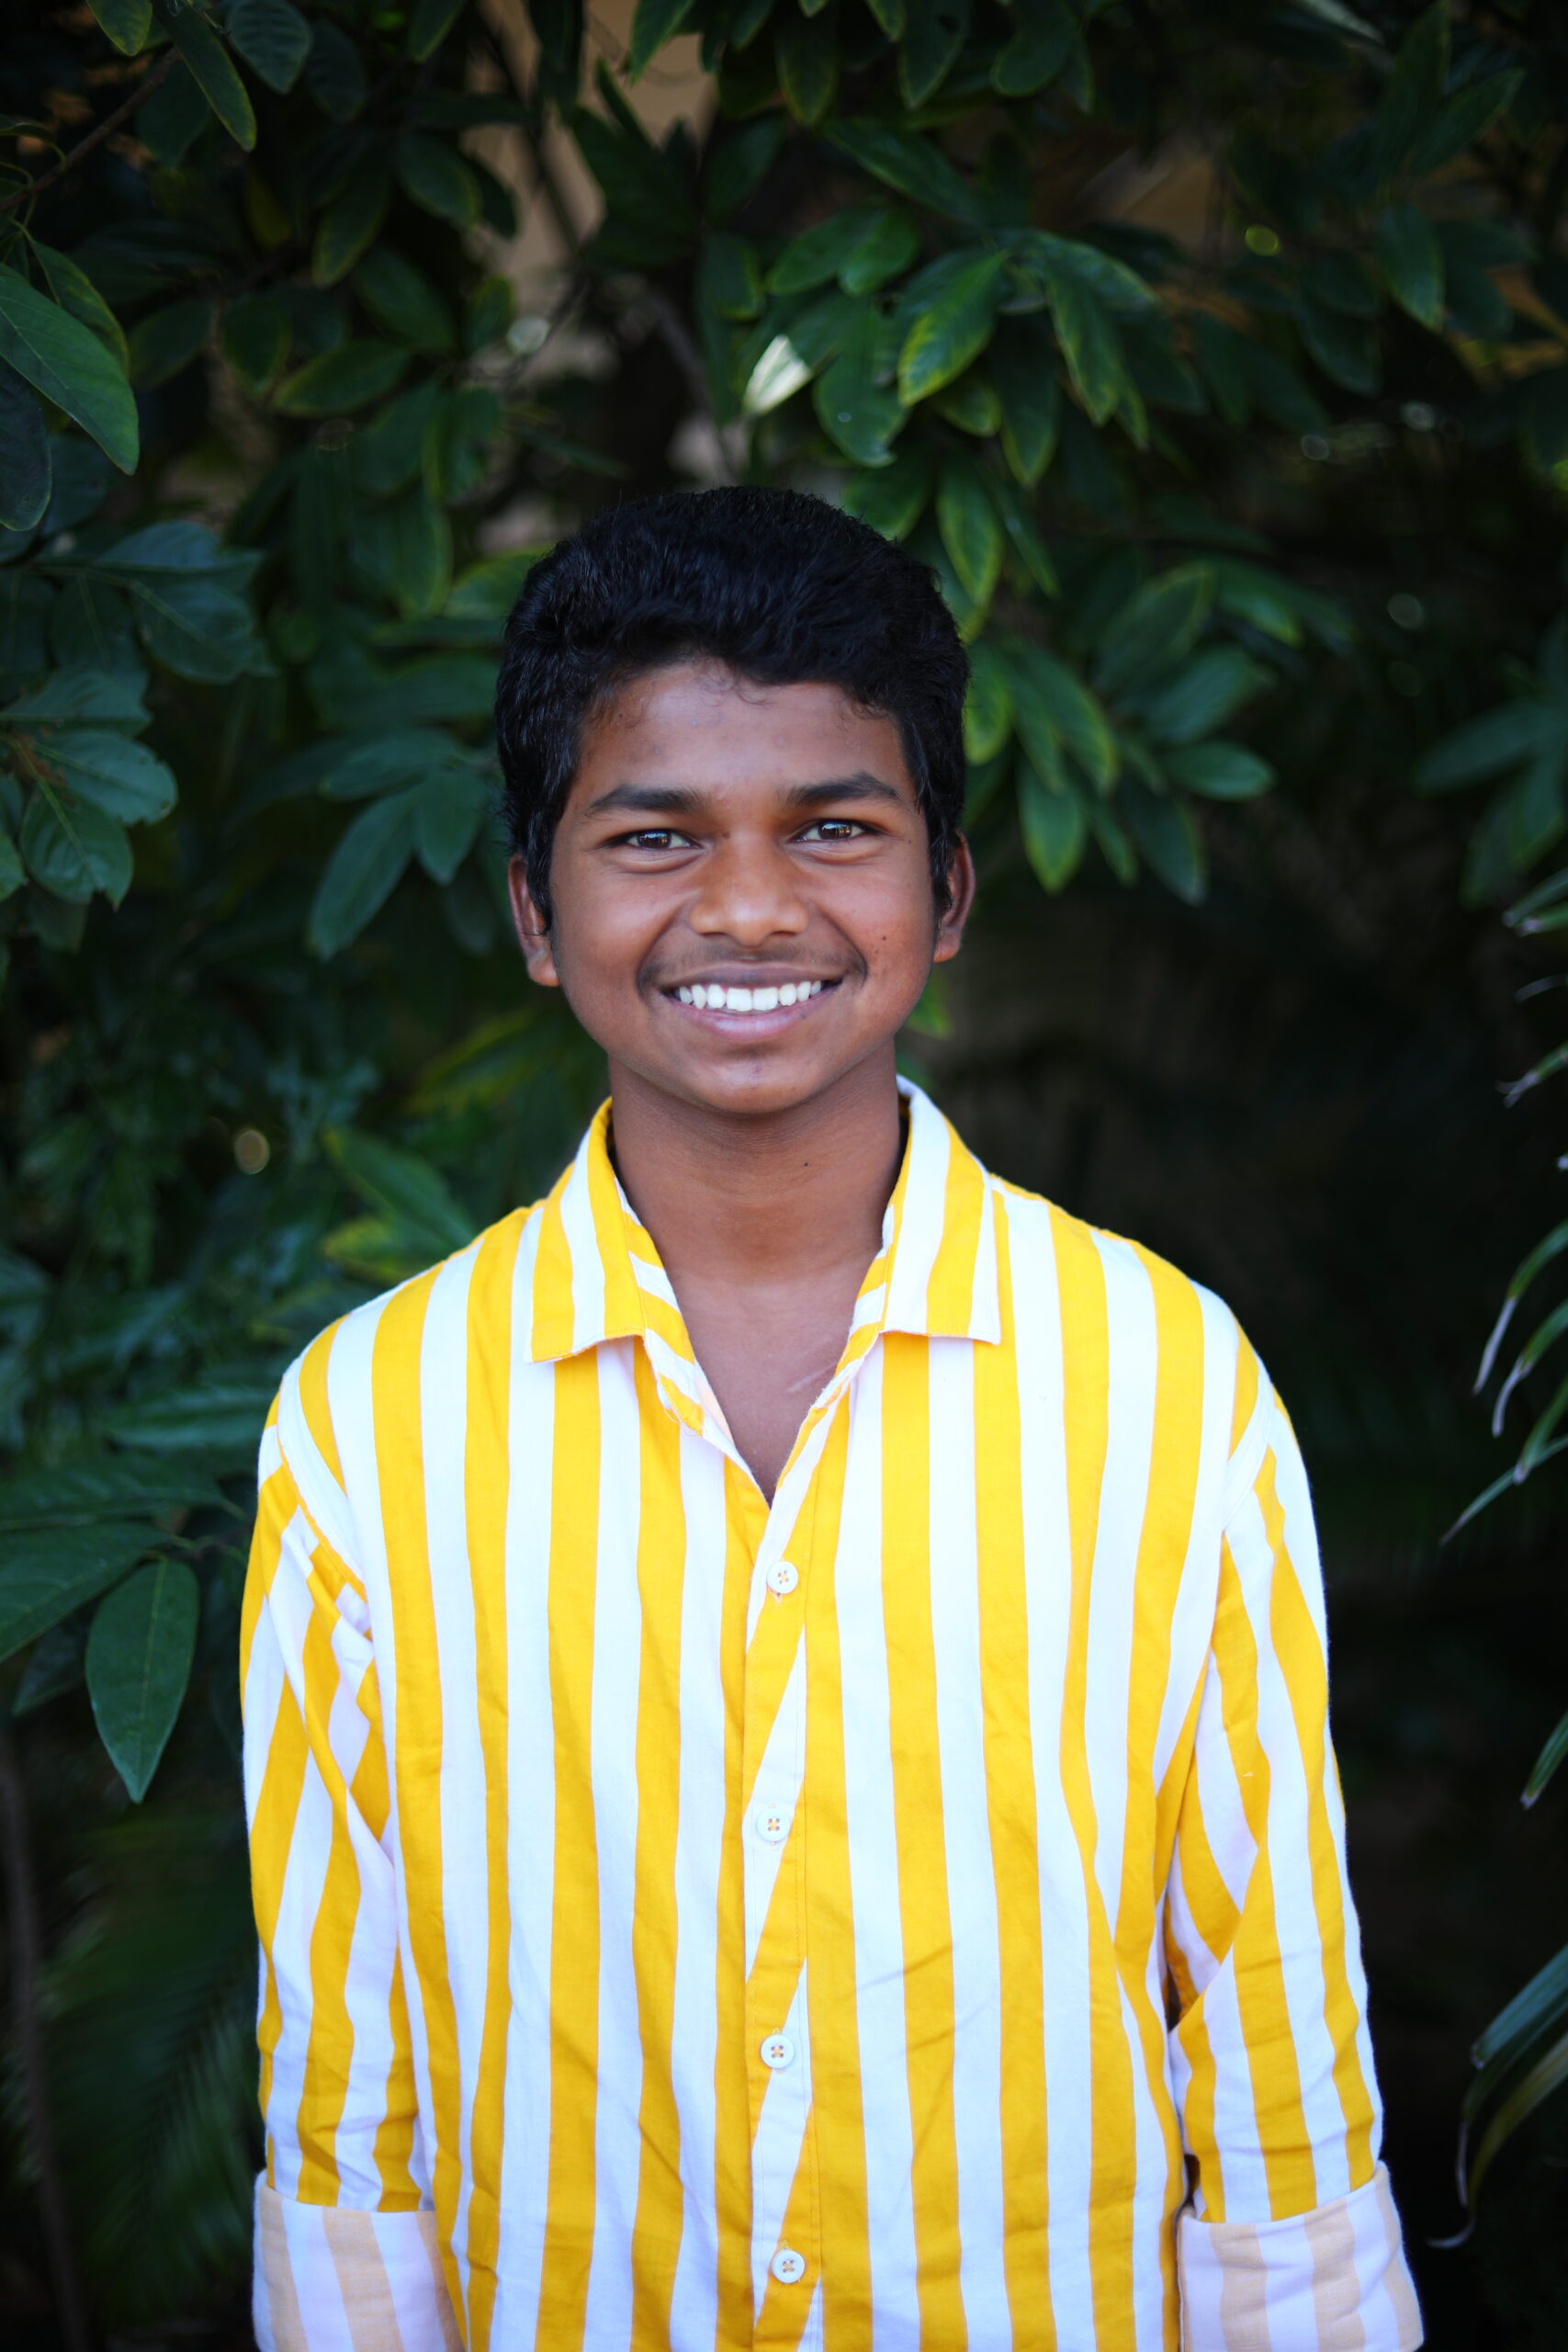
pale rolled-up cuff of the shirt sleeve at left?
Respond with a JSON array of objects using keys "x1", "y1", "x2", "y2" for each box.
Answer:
[{"x1": 252, "y1": 2178, "x2": 463, "y2": 2352}]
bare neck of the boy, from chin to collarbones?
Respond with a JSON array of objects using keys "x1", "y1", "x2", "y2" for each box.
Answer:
[{"x1": 611, "y1": 1046, "x2": 903, "y2": 1291}]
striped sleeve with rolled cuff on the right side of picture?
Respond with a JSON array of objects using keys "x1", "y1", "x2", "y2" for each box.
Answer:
[{"x1": 1166, "y1": 1350, "x2": 1420, "y2": 2352}]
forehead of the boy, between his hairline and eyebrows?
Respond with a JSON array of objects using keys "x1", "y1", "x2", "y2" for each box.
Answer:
[{"x1": 569, "y1": 661, "x2": 917, "y2": 807}]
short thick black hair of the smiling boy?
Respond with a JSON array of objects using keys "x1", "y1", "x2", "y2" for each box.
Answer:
[{"x1": 496, "y1": 487, "x2": 968, "y2": 922}]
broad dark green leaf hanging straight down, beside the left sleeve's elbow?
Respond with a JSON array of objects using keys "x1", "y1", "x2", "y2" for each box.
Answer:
[{"x1": 87, "y1": 1559, "x2": 202, "y2": 1804}]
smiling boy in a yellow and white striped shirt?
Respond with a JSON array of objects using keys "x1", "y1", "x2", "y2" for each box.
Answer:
[{"x1": 244, "y1": 489, "x2": 1420, "y2": 2352}]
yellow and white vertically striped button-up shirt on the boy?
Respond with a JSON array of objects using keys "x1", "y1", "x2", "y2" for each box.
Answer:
[{"x1": 243, "y1": 1087, "x2": 1420, "y2": 2352}]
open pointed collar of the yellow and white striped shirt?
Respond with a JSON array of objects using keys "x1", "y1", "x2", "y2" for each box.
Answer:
[{"x1": 529, "y1": 1077, "x2": 1001, "y2": 1363}]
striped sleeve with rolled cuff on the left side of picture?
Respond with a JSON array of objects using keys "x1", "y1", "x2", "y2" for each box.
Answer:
[{"x1": 243, "y1": 1374, "x2": 458, "y2": 2352}]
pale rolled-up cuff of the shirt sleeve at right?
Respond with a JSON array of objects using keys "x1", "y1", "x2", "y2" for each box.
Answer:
[{"x1": 1176, "y1": 2164, "x2": 1422, "y2": 2352}]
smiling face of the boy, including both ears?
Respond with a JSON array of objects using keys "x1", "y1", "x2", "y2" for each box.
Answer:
[{"x1": 513, "y1": 663, "x2": 974, "y2": 1114}]
